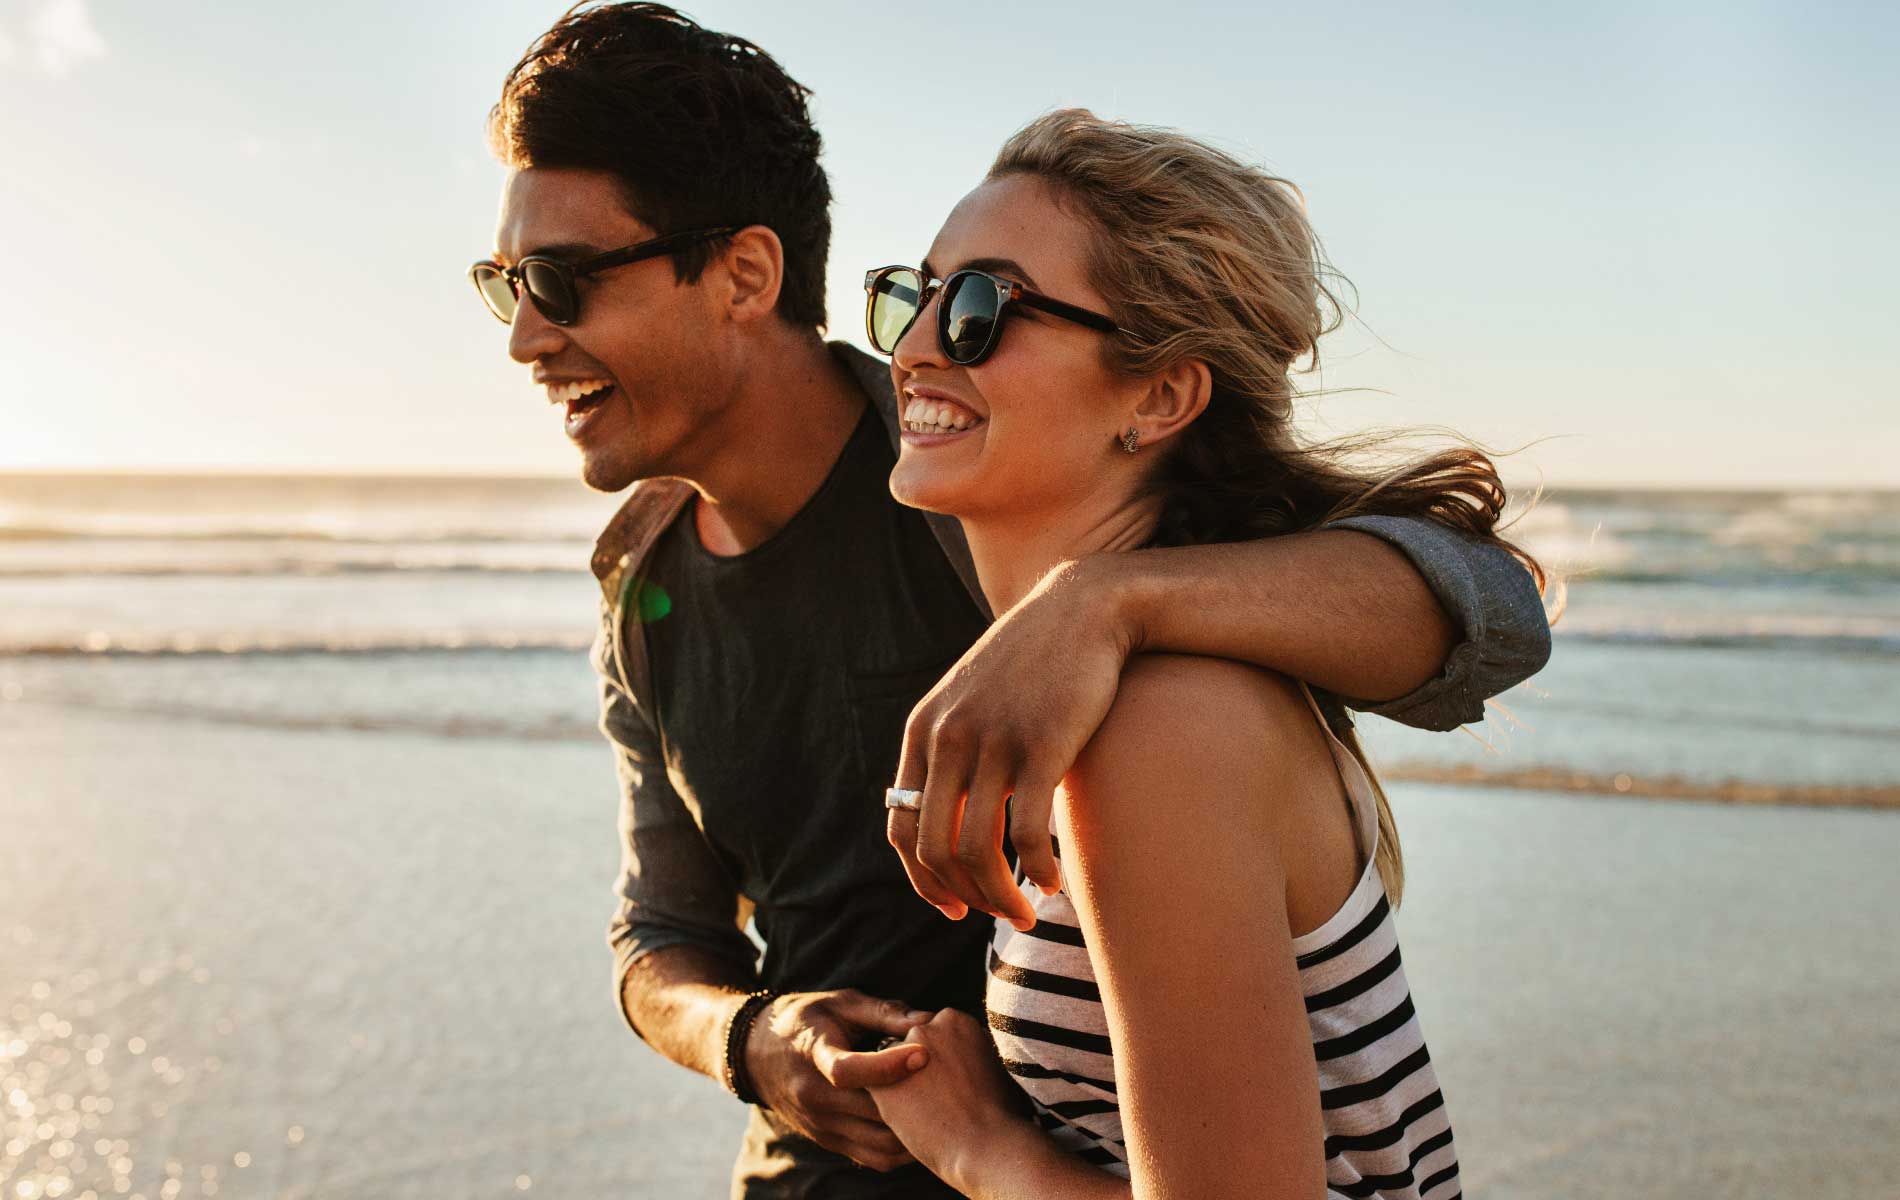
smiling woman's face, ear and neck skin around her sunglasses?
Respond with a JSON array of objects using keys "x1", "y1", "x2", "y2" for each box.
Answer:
[{"x1": 891, "y1": 175, "x2": 1208, "y2": 611}]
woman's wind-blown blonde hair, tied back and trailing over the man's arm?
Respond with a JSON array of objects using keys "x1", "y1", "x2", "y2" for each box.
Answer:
[{"x1": 990, "y1": 108, "x2": 1545, "y2": 904}]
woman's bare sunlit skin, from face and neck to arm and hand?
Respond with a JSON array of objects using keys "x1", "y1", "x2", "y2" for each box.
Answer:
[{"x1": 872, "y1": 177, "x2": 1364, "y2": 1200}]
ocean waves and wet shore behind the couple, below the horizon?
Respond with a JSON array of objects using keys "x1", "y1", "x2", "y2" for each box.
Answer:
[{"x1": 0, "y1": 475, "x2": 1900, "y2": 1200}]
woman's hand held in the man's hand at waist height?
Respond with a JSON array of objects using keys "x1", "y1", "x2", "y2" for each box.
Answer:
[{"x1": 870, "y1": 1008, "x2": 1039, "y2": 1194}]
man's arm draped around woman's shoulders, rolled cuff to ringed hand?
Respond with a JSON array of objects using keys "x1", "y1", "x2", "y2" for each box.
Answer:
[{"x1": 889, "y1": 516, "x2": 1550, "y2": 925}]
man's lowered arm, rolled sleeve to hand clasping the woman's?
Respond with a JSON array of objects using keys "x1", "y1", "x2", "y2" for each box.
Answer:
[{"x1": 595, "y1": 617, "x2": 927, "y2": 1170}]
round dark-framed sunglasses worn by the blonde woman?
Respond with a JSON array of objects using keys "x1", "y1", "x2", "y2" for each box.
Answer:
[{"x1": 865, "y1": 266, "x2": 1115, "y2": 366}]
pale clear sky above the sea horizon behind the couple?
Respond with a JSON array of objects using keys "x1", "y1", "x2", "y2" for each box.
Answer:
[{"x1": 0, "y1": 0, "x2": 1900, "y2": 486}]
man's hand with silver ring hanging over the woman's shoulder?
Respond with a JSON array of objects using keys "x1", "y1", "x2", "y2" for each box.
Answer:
[{"x1": 889, "y1": 560, "x2": 1134, "y2": 928}]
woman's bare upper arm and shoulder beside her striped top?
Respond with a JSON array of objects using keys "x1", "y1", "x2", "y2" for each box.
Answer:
[{"x1": 1058, "y1": 655, "x2": 1341, "y2": 1200}]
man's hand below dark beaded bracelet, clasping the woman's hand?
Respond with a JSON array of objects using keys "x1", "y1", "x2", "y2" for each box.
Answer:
[{"x1": 745, "y1": 991, "x2": 931, "y2": 1172}]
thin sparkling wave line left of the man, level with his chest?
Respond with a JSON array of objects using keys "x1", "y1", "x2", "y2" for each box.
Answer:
[{"x1": 0, "y1": 630, "x2": 593, "y2": 659}]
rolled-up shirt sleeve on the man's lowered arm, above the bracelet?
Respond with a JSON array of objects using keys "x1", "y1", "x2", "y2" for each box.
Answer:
[{"x1": 593, "y1": 606, "x2": 758, "y2": 1033}]
